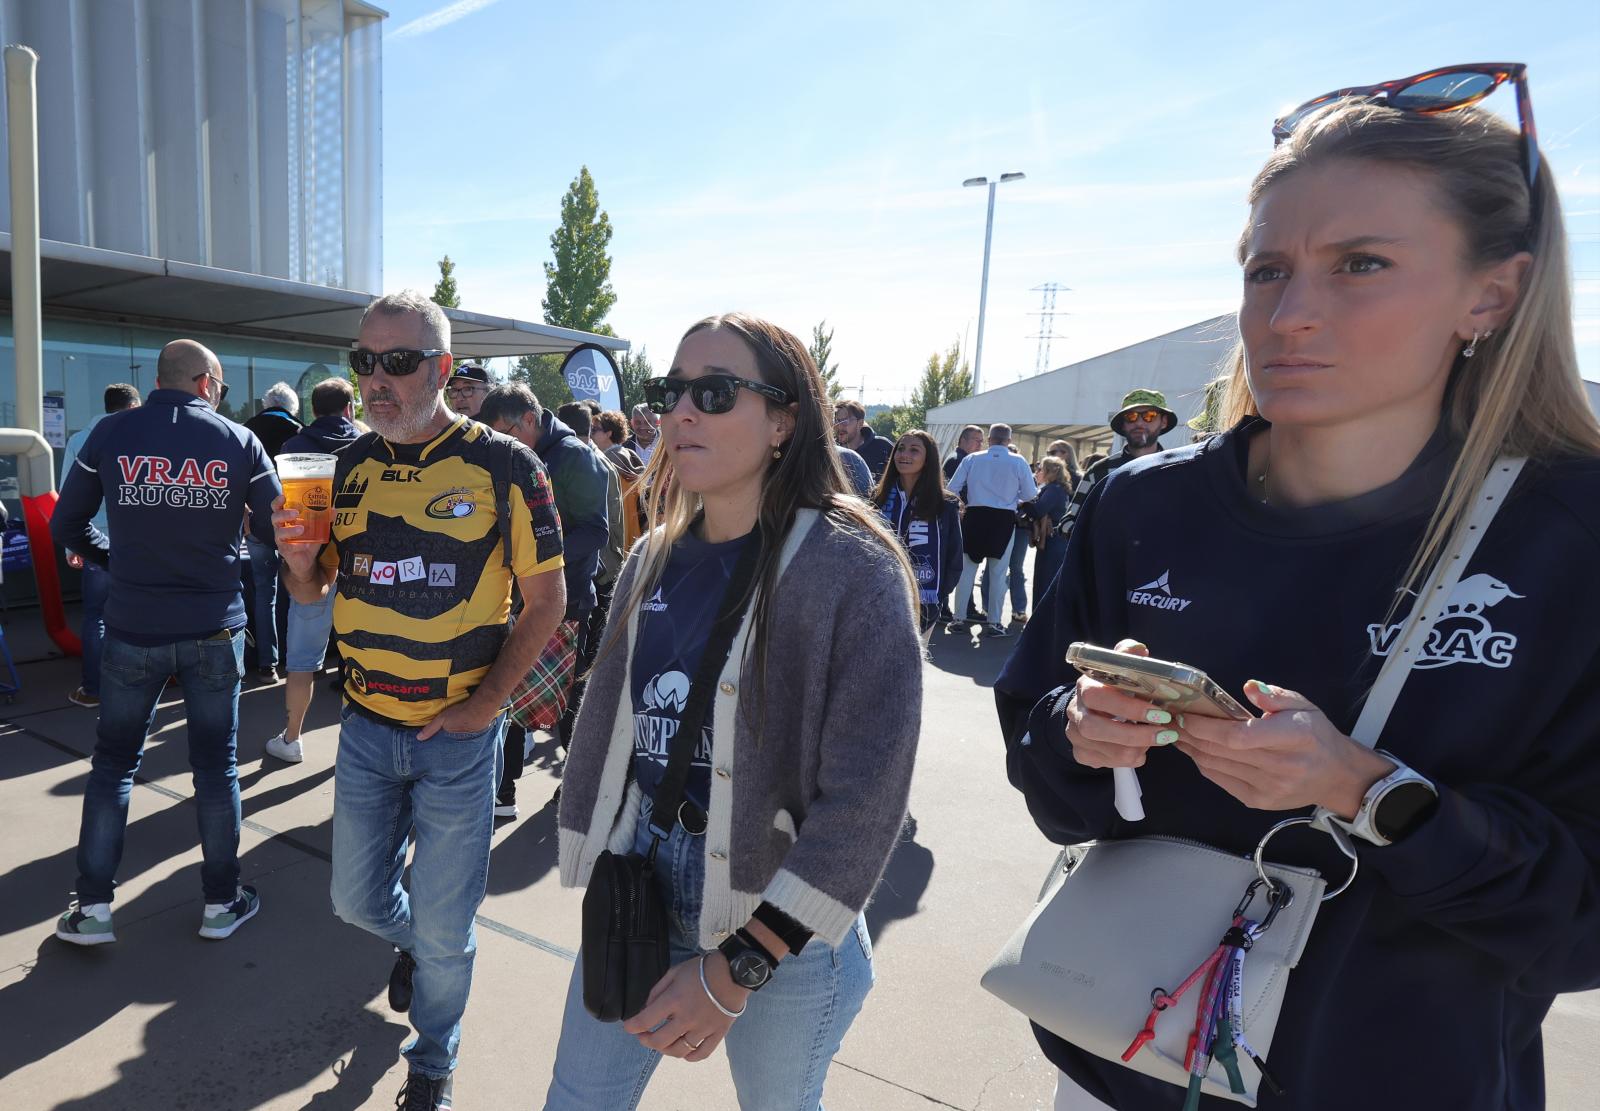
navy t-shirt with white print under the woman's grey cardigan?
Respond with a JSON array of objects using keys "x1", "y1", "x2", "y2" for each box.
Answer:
[{"x1": 630, "y1": 535, "x2": 750, "y2": 808}]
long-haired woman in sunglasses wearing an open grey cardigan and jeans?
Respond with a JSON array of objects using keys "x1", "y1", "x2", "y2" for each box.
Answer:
[{"x1": 546, "y1": 315, "x2": 922, "y2": 1111}]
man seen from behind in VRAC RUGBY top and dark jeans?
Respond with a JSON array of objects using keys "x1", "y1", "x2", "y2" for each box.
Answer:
[{"x1": 50, "y1": 339, "x2": 282, "y2": 945}]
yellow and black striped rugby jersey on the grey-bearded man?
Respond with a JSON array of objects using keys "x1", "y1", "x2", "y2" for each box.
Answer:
[{"x1": 322, "y1": 416, "x2": 562, "y2": 725}]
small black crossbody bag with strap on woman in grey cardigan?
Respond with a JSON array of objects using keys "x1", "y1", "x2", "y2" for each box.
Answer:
[{"x1": 582, "y1": 530, "x2": 762, "y2": 1023}]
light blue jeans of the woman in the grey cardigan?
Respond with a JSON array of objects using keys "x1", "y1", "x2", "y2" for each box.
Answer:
[{"x1": 544, "y1": 804, "x2": 872, "y2": 1111}]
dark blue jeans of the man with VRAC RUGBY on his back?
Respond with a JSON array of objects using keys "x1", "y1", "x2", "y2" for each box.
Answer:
[{"x1": 77, "y1": 629, "x2": 245, "y2": 904}]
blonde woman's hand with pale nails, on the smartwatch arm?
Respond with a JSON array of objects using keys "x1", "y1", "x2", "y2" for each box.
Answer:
[{"x1": 1178, "y1": 680, "x2": 1394, "y2": 818}]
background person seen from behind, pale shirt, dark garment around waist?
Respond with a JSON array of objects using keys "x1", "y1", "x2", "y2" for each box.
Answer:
[{"x1": 946, "y1": 424, "x2": 1038, "y2": 637}]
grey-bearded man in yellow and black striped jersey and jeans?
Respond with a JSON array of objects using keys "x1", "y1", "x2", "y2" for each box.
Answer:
[{"x1": 272, "y1": 291, "x2": 566, "y2": 1109}]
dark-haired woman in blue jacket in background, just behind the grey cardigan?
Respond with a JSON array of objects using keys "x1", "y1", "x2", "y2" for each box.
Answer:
[{"x1": 872, "y1": 429, "x2": 962, "y2": 644}]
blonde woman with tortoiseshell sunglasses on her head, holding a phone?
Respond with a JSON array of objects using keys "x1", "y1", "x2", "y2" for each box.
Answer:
[{"x1": 997, "y1": 66, "x2": 1600, "y2": 1111}]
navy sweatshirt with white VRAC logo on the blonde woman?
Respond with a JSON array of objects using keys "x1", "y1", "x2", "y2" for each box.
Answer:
[{"x1": 997, "y1": 419, "x2": 1600, "y2": 1111}]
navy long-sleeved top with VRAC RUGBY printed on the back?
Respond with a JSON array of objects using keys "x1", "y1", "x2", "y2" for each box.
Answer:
[{"x1": 50, "y1": 389, "x2": 283, "y2": 645}]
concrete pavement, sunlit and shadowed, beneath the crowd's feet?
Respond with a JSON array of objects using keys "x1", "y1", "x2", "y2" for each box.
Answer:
[{"x1": 0, "y1": 613, "x2": 1600, "y2": 1111}]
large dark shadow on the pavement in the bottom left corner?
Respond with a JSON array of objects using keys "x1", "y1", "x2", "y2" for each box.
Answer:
[{"x1": 0, "y1": 808, "x2": 410, "y2": 1111}]
